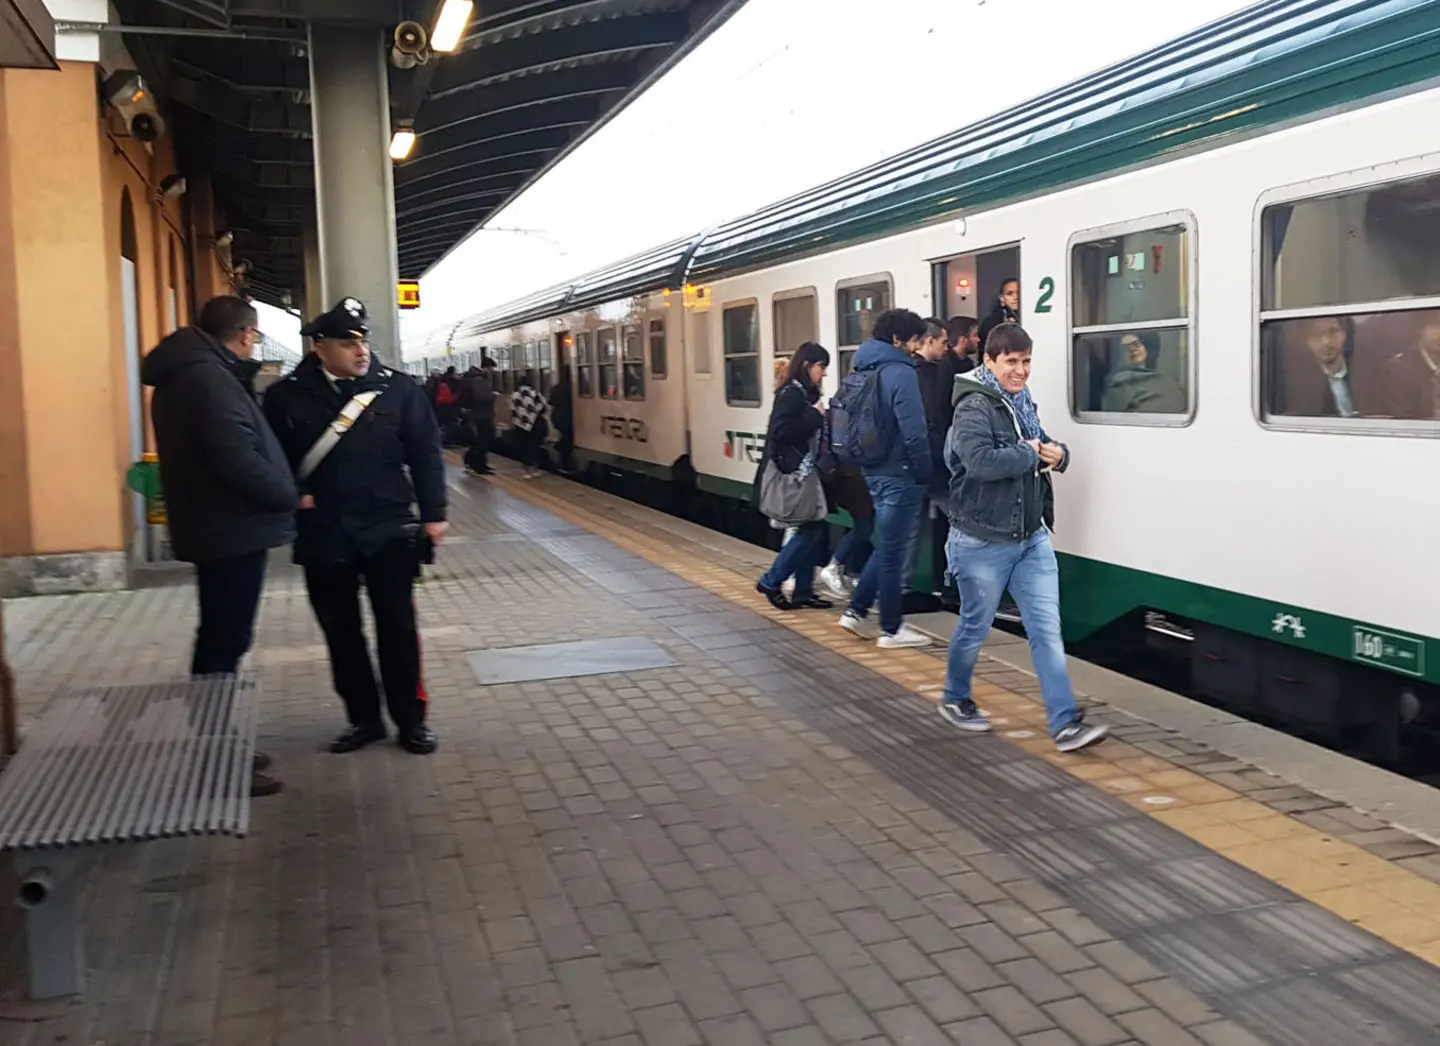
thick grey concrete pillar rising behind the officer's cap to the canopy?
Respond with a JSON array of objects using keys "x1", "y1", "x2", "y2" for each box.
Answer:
[{"x1": 307, "y1": 24, "x2": 400, "y2": 363}]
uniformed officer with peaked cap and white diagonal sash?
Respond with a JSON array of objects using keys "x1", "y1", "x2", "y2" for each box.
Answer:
[{"x1": 265, "y1": 298, "x2": 449, "y2": 755}]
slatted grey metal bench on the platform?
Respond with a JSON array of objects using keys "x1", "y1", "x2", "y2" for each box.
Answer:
[{"x1": 0, "y1": 676, "x2": 256, "y2": 1000}]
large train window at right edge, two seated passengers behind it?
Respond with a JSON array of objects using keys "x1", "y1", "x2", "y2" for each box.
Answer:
[{"x1": 1260, "y1": 174, "x2": 1440, "y2": 437}]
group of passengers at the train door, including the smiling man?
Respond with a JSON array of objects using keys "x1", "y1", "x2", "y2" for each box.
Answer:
[{"x1": 755, "y1": 280, "x2": 1106, "y2": 752}]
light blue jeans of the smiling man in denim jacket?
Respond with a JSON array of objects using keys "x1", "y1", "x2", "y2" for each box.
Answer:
[{"x1": 945, "y1": 527, "x2": 1080, "y2": 736}]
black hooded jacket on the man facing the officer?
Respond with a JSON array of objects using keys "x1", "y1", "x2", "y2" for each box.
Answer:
[{"x1": 140, "y1": 327, "x2": 300, "y2": 563}]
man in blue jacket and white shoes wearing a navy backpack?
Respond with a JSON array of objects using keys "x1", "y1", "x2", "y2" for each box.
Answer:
[{"x1": 838, "y1": 308, "x2": 933, "y2": 650}]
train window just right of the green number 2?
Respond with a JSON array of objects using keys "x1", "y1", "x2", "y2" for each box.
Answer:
[{"x1": 1070, "y1": 215, "x2": 1195, "y2": 425}]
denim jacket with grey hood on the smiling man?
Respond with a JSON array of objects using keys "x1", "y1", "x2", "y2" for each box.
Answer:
[{"x1": 945, "y1": 377, "x2": 1070, "y2": 543}]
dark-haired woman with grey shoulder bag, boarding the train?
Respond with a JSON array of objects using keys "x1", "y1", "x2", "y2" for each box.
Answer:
[{"x1": 753, "y1": 341, "x2": 834, "y2": 609}]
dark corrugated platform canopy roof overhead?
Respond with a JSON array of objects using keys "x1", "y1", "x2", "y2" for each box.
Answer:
[{"x1": 114, "y1": 0, "x2": 744, "y2": 304}]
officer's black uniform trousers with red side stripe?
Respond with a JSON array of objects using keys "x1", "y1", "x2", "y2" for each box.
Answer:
[{"x1": 305, "y1": 537, "x2": 428, "y2": 729}]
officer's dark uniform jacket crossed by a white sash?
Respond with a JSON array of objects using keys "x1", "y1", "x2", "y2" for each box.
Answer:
[{"x1": 265, "y1": 353, "x2": 445, "y2": 566}]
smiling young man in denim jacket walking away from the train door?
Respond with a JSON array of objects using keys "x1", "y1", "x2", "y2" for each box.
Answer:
[{"x1": 940, "y1": 323, "x2": 1107, "y2": 752}]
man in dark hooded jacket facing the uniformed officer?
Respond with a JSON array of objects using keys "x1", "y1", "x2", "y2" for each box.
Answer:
[{"x1": 140, "y1": 295, "x2": 300, "y2": 795}]
